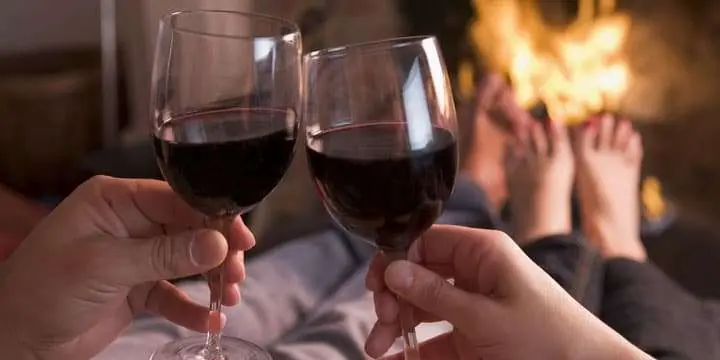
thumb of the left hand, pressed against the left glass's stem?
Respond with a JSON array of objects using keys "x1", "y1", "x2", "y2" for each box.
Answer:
[{"x1": 123, "y1": 230, "x2": 228, "y2": 285}]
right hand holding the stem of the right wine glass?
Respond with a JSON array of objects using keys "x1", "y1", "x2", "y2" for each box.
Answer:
[{"x1": 366, "y1": 225, "x2": 650, "y2": 360}]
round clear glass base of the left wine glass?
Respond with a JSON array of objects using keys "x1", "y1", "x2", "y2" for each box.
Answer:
[{"x1": 150, "y1": 336, "x2": 272, "y2": 360}]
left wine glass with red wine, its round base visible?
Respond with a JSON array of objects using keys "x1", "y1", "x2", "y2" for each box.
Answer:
[{"x1": 151, "y1": 10, "x2": 302, "y2": 360}]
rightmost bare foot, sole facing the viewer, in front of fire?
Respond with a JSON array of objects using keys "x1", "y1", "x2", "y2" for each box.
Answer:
[{"x1": 575, "y1": 115, "x2": 647, "y2": 262}]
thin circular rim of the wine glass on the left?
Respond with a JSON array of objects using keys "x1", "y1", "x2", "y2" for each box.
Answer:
[{"x1": 160, "y1": 9, "x2": 300, "y2": 40}]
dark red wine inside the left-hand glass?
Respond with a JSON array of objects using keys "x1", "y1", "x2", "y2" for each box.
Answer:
[{"x1": 153, "y1": 108, "x2": 297, "y2": 216}]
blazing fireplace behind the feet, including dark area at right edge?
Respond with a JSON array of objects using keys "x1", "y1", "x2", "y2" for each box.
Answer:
[{"x1": 456, "y1": 0, "x2": 720, "y2": 222}]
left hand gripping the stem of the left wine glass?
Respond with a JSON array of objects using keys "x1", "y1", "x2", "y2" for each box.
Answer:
[{"x1": 0, "y1": 177, "x2": 254, "y2": 360}]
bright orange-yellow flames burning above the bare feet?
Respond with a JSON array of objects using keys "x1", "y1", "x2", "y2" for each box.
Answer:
[{"x1": 470, "y1": 0, "x2": 631, "y2": 123}]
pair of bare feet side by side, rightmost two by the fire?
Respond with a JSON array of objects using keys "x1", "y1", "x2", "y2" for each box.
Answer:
[{"x1": 505, "y1": 115, "x2": 646, "y2": 261}]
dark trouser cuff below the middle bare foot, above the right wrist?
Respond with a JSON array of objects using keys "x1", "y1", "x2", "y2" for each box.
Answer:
[{"x1": 524, "y1": 235, "x2": 603, "y2": 314}]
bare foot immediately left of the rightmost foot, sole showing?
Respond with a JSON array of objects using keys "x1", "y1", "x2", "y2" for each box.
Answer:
[{"x1": 507, "y1": 123, "x2": 574, "y2": 245}]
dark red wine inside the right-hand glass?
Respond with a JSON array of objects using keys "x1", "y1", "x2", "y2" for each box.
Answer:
[{"x1": 307, "y1": 123, "x2": 457, "y2": 251}]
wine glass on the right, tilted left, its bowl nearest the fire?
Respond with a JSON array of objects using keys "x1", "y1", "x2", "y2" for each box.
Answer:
[{"x1": 303, "y1": 37, "x2": 458, "y2": 360}]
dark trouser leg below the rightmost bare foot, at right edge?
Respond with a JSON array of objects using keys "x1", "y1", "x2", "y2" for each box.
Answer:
[{"x1": 601, "y1": 259, "x2": 720, "y2": 360}]
